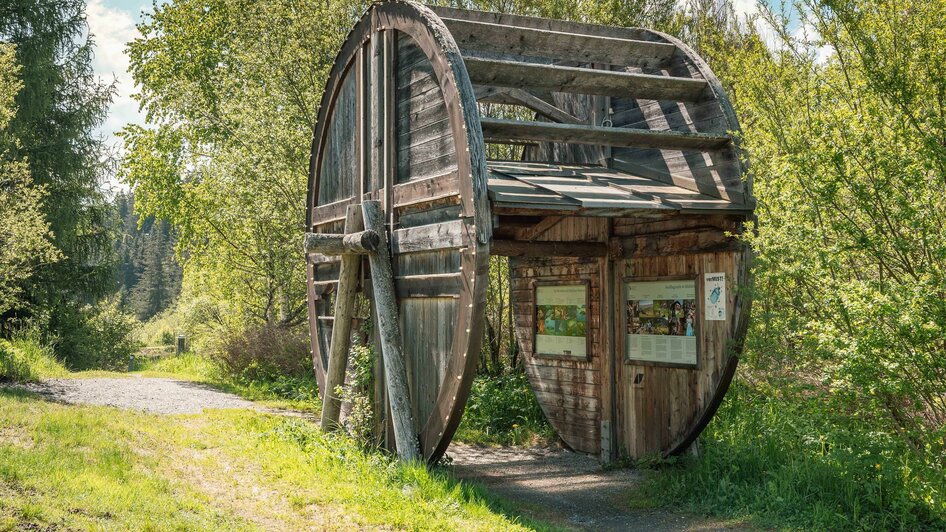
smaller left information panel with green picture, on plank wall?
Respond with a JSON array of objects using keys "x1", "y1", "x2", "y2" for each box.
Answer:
[{"x1": 535, "y1": 284, "x2": 588, "y2": 358}]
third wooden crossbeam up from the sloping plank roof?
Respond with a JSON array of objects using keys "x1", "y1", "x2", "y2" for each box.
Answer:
[{"x1": 442, "y1": 18, "x2": 677, "y2": 66}]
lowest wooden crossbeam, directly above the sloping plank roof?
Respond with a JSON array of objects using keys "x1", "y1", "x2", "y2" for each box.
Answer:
[{"x1": 480, "y1": 118, "x2": 730, "y2": 150}]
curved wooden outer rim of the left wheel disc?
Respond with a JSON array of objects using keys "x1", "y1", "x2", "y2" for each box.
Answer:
[{"x1": 306, "y1": 2, "x2": 490, "y2": 461}]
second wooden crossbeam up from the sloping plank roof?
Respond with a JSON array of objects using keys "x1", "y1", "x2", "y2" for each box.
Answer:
[{"x1": 464, "y1": 57, "x2": 709, "y2": 102}]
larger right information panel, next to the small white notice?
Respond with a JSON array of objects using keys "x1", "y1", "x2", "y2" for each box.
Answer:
[{"x1": 624, "y1": 279, "x2": 699, "y2": 366}]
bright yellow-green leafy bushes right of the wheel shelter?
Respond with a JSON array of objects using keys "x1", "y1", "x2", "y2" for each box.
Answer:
[{"x1": 725, "y1": 2, "x2": 946, "y2": 465}]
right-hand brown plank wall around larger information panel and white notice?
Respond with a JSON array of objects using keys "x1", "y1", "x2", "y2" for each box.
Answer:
[{"x1": 612, "y1": 217, "x2": 746, "y2": 457}]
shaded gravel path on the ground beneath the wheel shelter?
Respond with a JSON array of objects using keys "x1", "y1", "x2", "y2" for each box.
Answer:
[{"x1": 447, "y1": 443, "x2": 741, "y2": 531}]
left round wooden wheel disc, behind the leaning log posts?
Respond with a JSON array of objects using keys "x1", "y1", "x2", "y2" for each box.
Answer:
[{"x1": 307, "y1": 2, "x2": 490, "y2": 459}]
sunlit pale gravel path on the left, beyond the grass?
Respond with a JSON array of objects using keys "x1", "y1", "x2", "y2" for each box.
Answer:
[{"x1": 24, "y1": 377, "x2": 262, "y2": 414}]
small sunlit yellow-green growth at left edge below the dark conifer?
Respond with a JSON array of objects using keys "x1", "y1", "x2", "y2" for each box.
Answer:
[{"x1": 0, "y1": 329, "x2": 69, "y2": 382}]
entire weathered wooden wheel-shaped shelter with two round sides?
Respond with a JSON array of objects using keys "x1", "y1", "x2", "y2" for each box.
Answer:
[{"x1": 307, "y1": 2, "x2": 754, "y2": 460}]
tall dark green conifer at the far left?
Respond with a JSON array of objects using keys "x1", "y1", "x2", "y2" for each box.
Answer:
[{"x1": 0, "y1": 0, "x2": 113, "y2": 358}]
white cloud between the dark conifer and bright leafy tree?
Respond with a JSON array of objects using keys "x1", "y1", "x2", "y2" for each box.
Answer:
[{"x1": 86, "y1": 0, "x2": 144, "y2": 150}]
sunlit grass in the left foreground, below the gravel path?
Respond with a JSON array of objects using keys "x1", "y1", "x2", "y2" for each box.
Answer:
[{"x1": 0, "y1": 389, "x2": 547, "y2": 530}]
